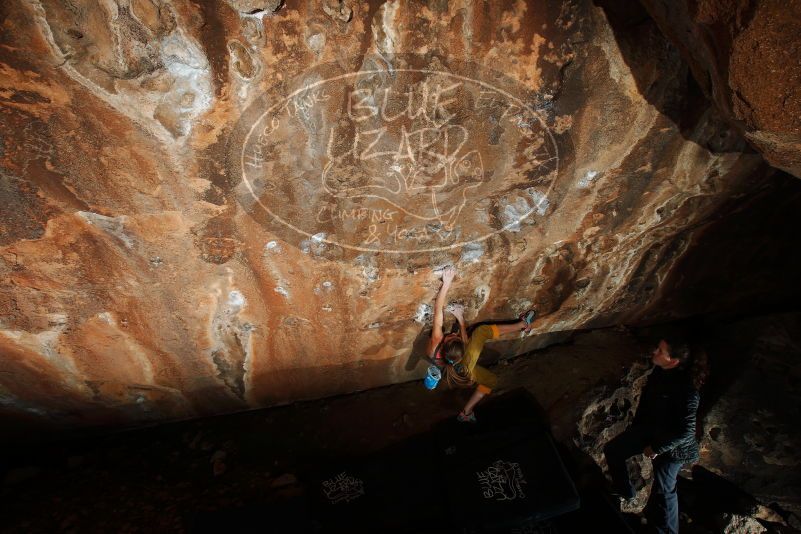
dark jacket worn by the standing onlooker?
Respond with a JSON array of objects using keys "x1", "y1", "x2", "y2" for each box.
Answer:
[{"x1": 632, "y1": 367, "x2": 700, "y2": 463}]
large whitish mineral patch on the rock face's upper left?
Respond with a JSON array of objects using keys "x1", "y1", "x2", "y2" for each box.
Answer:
[{"x1": 30, "y1": 0, "x2": 213, "y2": 142}]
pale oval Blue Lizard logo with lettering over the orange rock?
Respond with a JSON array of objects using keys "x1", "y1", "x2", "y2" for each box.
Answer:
[{"x1": 229, "y1": 56, "x2": 559, "y2": 261}]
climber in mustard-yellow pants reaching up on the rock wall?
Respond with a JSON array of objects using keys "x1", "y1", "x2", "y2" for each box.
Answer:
[{"x1": 428, "y1": 267, "x2": 535, "y2": 423}]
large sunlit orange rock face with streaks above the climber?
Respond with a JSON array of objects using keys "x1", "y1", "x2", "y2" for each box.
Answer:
[{"x1": 0, "y1": 0, "x2": 780, "y2": 434}]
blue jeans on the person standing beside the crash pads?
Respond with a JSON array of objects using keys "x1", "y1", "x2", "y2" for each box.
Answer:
[{"x1": 604, "y1": 427, "x2": 684, "y2": 534}]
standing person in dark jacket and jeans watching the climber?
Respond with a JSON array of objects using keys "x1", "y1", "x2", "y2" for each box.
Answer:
[{"x1": 604, "y1": 339, "x2": 708, "y2": 534}]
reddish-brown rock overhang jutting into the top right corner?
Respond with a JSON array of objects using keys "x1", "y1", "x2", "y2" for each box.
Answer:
[{"x1": 642, "y1": 0, "x2": 801, "y2": 177}]
